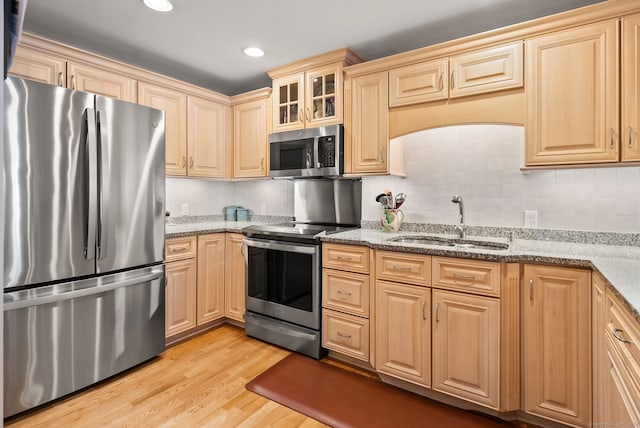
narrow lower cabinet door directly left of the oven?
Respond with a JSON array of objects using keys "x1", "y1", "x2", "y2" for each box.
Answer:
[{"x1": 224, "y1": 233, "x2": 246, "y2": 322}]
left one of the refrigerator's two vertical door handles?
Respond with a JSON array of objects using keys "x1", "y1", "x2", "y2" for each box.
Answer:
[{"x1": 83, "y1": 108, "x2": 98, "y2": 260}]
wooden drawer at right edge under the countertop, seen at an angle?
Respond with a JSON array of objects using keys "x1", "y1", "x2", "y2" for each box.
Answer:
[{"x1": 606, "y1": 294, "x2": 640, "y2": 387}]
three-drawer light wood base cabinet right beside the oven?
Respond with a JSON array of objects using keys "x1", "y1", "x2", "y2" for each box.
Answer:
[{"x1": 322, "y1": 243, "x2": 374, "y2": 364}]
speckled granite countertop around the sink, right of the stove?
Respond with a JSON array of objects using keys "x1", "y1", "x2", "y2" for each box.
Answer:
[{"x1": 322, "y1": 229, "x2": 640, "y2": 323}]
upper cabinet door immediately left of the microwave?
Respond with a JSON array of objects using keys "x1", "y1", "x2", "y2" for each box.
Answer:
[{"x1": 233, "y1": 99, "x2": 267, "y2": 178}]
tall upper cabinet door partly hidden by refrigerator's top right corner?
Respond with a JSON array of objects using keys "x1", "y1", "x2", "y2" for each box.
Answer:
[{"x1": 138, "y1": 82, "x2": 187, "y2": 176}]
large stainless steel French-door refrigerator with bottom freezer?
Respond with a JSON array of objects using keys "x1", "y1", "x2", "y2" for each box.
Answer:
[{"x1": 2, "y1": 77, "x2": 165, "y2": 417}]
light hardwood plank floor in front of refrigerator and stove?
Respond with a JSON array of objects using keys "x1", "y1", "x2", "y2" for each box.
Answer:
[{"x1": 5, "y1": 325, "x2": 324, "y2": 428}]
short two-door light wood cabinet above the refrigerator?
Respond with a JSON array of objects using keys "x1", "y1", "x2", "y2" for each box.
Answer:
[{"x1": 9, "y1": 46, "x2": 138, "y2": 103}]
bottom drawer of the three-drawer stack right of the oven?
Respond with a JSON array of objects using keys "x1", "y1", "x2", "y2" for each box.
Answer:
[{"x1": 322, "y1": 309, "x2": 369, "y2": 361}]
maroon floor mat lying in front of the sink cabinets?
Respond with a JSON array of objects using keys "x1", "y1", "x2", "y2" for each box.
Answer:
[{"x1": 246, "y1": 354, "x2": 512, "y2": 428}]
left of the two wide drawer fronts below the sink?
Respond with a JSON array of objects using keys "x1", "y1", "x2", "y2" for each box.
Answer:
[{"x1": 376, "y1": 251, "x2": 431, "y2": 286}]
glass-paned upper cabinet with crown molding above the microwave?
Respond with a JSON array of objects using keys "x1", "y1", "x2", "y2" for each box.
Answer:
[{"x1": 268, "y1": 49, "x2": 361, "y2": 132}]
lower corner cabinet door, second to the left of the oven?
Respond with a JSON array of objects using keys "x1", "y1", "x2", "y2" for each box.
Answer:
[{"x1": 197, "y1": 233, "x2": 225, "y2": 325}]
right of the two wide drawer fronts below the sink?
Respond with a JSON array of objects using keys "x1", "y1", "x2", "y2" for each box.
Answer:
[{"x1": 433, "y1": 257, "x2": 500, "y2": 297}]
